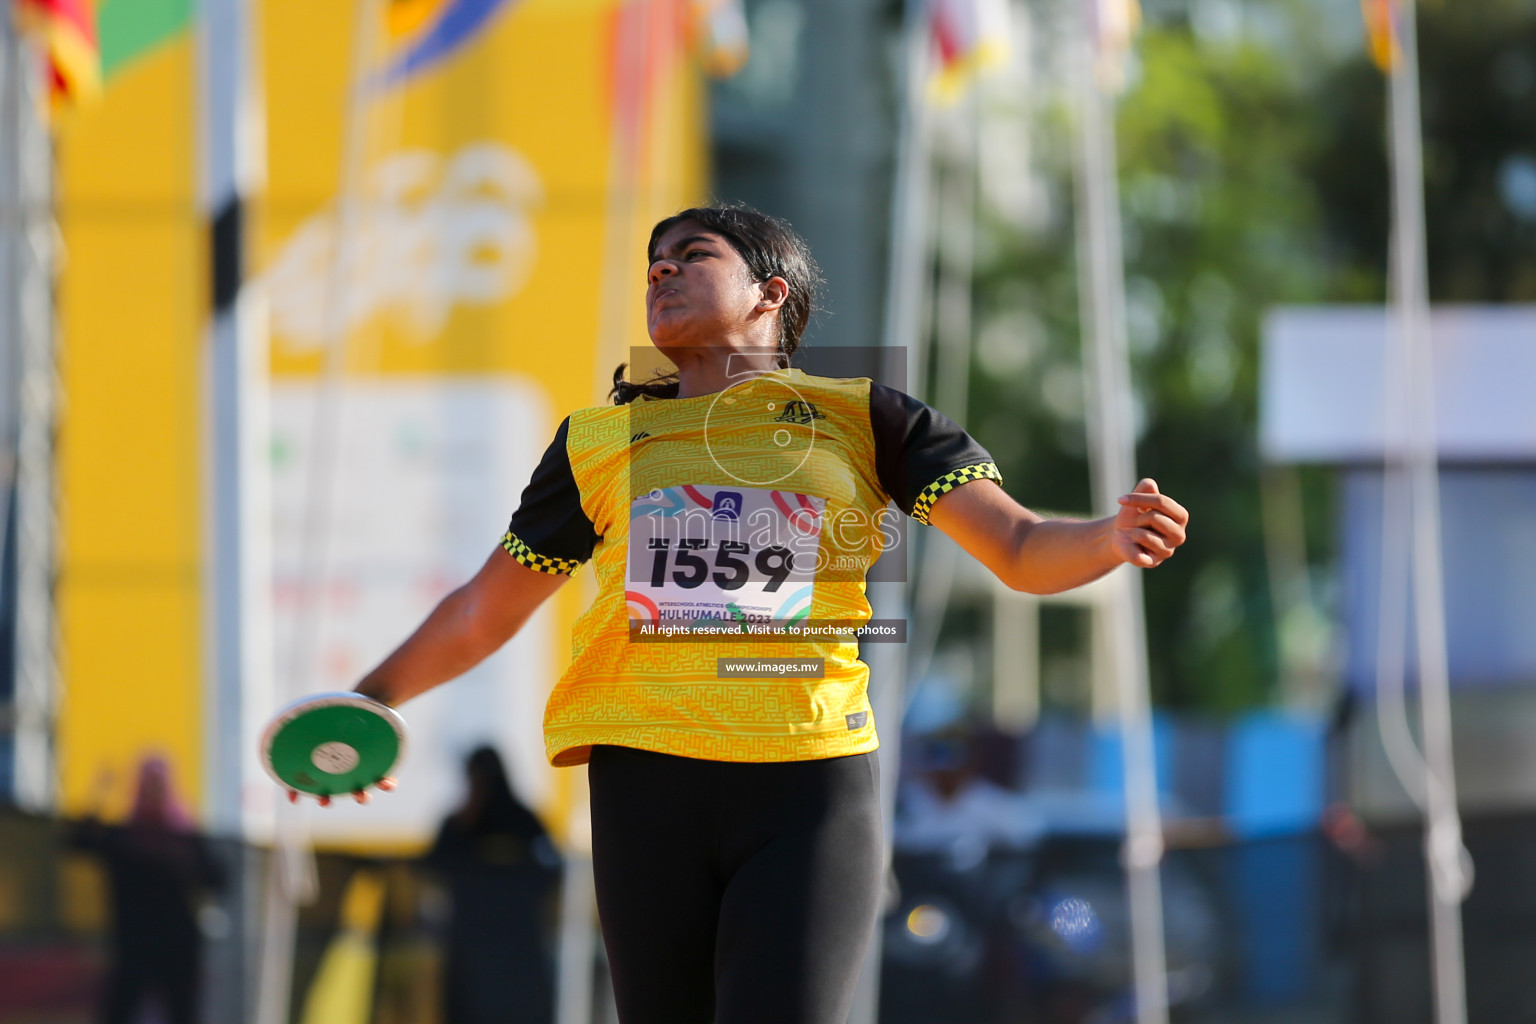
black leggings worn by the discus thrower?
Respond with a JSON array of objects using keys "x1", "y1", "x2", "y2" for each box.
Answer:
[{"x1": 588, "y1": 746, "x2": 882, "y2": 1024}]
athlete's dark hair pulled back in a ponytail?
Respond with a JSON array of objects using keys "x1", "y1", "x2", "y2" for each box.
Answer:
[{"x1": 610, "y1": 203, "x2": 822, "y2": 405}]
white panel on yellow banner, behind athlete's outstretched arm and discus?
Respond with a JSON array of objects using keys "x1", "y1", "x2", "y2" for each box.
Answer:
[{"x1": 261, "y1": 378, "x2": 551, "y2": 841}]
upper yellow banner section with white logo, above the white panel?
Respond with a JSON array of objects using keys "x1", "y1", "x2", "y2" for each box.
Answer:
[{"x1": 261, "y1": 0, "x2": 705, "y2": 388}]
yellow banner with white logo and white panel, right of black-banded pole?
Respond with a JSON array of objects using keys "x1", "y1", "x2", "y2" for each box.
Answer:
[{"x1": 252, "y1": 0, "x2": 703, "y2": 843}]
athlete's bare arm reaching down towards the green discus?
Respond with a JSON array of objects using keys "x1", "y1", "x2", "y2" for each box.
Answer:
[{"x1": 356, "y1": 548, "x2": 568, "y2": 706}]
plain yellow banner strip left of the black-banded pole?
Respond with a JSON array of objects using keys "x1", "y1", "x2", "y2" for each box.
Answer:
[{"x1": 55, "y1": 34, "x2": 210, "y2": 814}]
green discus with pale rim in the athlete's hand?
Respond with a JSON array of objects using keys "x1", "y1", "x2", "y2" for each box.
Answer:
[{"x1": 261, "y1": 692, "x2": 406, "y2": 797}]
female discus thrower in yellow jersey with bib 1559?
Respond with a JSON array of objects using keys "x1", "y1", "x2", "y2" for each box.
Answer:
[{"x1": 333, "y1": 207, "x2": 1189, "y2": 1024}]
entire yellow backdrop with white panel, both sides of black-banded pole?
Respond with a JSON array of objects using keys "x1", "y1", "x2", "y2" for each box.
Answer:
[{"x1": 58, "y1": 0, "x2": 705, "y2": 843}]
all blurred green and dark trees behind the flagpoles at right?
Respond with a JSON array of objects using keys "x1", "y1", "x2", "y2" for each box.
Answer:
[{"x1": 971, "y1": 0, "x2": 1536, "y2": 711}]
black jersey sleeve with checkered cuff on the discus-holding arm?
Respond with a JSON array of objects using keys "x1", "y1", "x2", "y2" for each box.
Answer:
[{"x1": 501, "y1": 416, "x2": 599, "y2": 576}]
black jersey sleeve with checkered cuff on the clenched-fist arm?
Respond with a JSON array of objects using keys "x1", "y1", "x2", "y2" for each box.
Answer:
[{"x1": 869, "y1": 384, "x2": 1003, "y2": 524}]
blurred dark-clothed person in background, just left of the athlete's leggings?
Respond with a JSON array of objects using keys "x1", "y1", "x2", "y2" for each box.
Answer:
[{"x1": 425, "y1": 746, "x2": 561, "y2": 1024}]
